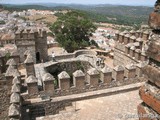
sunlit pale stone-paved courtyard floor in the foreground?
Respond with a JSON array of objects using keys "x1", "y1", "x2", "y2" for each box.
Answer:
[{"x1": 37, "y1": 90, "x2": 142, "y2": 120}]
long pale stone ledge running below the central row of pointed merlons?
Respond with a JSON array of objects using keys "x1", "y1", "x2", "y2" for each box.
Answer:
[{"x1": 26, "y1": 82, "x2": 144, "y2": 104}]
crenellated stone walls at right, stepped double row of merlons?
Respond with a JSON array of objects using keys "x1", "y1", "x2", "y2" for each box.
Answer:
[{"x1": 114, "y1": 30, "x2": 150, "y2": 65}]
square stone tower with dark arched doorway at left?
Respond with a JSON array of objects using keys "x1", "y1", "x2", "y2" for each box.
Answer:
[{"x1": 15, "y1": 29, "x2": 48, "y2": 63}]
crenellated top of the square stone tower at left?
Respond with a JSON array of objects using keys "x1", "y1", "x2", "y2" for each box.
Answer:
[{"x1": 15, "y1": 29, "x2": 47, "y2": 40}]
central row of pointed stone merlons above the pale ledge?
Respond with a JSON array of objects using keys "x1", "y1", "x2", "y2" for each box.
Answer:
[{"x1": 22, "y1": 53, "x2": 147, "y2": 98}]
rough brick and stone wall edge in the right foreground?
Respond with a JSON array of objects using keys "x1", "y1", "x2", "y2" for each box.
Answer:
[{"x1": 138, "y1": 0, "x2": 160, "y2": 120}]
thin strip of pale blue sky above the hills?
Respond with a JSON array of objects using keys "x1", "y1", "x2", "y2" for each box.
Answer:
[{"x1": 0, "y1": 0, "x2": 156, "y2": 6}]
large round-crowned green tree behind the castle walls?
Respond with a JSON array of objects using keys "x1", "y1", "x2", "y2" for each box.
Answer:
[{"x1": 50, "y1": 11, "x2": 96, "y2": 52}]
